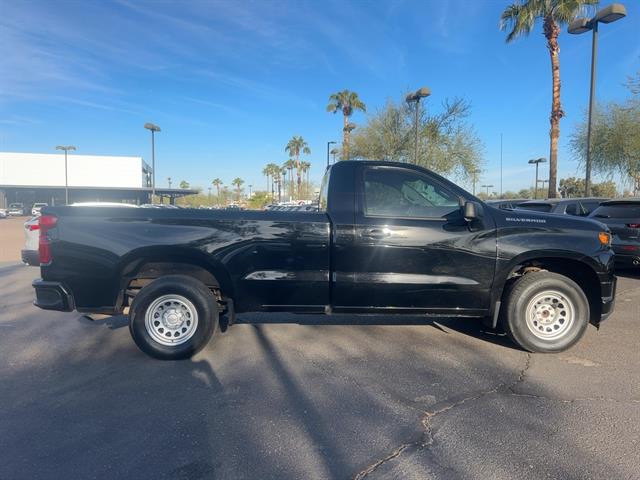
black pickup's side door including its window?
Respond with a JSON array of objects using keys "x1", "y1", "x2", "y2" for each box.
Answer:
[{"x1": 332, "y1": 163, "x2": 496, "y2": 315}]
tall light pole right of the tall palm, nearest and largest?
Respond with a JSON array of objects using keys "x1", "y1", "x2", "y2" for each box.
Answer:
[{"x1": 567, "y1": 3, "x2": 627, "y2": 197}]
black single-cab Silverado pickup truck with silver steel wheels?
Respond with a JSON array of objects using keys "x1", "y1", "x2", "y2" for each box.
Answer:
[{"x1": 33, "y1": 161, "x2": 616, "y2": 359}]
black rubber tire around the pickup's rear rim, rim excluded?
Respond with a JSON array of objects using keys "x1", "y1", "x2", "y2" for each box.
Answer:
[{"x1": 129, "y1": 275, "x2": 218, "y2": 360}]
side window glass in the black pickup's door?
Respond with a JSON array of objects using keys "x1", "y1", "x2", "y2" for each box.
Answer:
[{"x1": 364, "y1": 168, "x2": 459, "y2": 218}]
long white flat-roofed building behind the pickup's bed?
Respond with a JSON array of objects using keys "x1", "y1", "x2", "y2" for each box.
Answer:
[{"x1": 0, "y1": 152, "x2": 197, "y2": 208}]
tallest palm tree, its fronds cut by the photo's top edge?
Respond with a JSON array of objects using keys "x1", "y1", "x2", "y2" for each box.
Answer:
[{"x1": 500, "y1": 0, "x2": 598, "y2": 198}]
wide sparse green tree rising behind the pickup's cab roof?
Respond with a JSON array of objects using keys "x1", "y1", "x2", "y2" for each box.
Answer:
[{"x1": 353, "y1": 95, "x2": 483, "y2": 179}]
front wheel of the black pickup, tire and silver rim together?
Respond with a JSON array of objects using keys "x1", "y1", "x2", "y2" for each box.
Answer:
[{"x1": 501, "y1": 272, "x2": 590, "y2": 353}]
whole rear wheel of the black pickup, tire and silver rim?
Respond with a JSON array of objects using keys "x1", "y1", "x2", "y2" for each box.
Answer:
[{"x1": 129, "y1": 275, "x2": 218, "y2": 360}]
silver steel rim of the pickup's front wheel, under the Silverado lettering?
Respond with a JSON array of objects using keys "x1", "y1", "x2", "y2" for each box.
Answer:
[{"x1": 526, "y1": 290, "x2": 575, "y2": 340}]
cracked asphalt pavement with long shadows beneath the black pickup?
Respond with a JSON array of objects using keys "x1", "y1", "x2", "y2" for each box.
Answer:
[{"x1": 0, "y1": 265, "x2": 640, "y2": 480}]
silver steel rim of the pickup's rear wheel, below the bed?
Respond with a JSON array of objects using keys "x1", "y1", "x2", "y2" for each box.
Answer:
[{"x1": 144, "y1": 294, "x2": 198, "y2": 347}]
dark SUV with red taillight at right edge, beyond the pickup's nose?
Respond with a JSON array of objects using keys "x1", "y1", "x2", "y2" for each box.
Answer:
[{"x1": 590, "y1": 198, "x2": 640, "y2": 268}]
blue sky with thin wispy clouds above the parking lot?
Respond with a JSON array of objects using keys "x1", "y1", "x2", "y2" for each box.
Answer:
[{"x1": 0, "y1": 0, "x2": 640, "y2": 194}]
